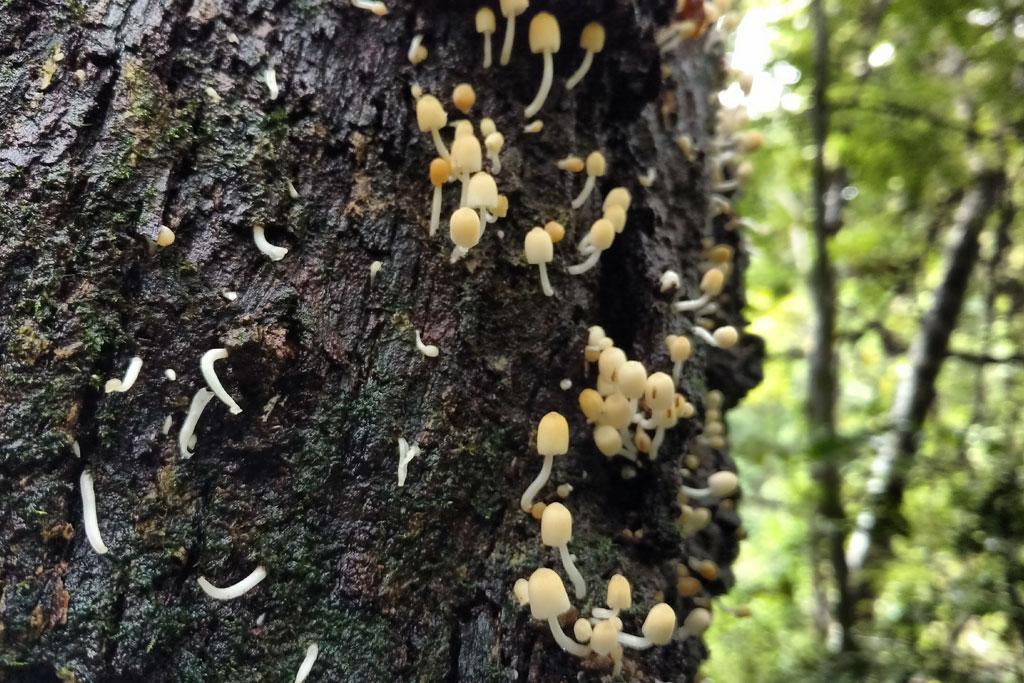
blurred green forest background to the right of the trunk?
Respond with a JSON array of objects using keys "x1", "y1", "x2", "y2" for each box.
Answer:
[{"x1": 705, "y1": 0, "x2": 1024, "y2": 681}]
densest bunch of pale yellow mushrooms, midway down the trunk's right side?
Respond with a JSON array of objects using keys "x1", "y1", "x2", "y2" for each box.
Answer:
[{"x1": 580, "y1": 326, "x2": 694, "y2": 462}]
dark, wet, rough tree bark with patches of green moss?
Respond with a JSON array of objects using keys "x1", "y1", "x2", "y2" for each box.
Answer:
[{"x1": 0, "y1": 0, "x2": 761, "y2": 681}]
